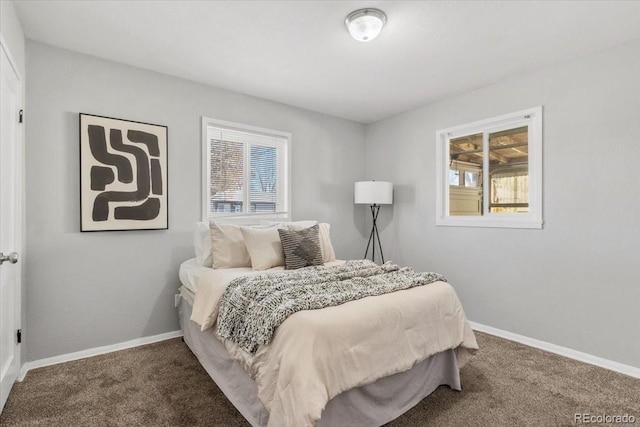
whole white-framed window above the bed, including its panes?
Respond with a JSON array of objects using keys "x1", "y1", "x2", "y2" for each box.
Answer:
[{"x1": 202, "y1": 117, "x2": 291, "y2": 221}]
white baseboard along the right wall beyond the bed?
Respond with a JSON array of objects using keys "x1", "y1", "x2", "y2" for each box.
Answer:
[{"x1": 469, "y1": 322, "x2": 640, "y2": 378}]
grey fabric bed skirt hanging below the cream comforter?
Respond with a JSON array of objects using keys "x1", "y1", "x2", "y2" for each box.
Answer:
[{"x1": 178, "y1": 298, "x2": 461, "y2": 427}]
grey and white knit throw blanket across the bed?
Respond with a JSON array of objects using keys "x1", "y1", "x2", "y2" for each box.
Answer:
[{"x1": 217, "y1": 260, "x2": 446, "y2": 354}]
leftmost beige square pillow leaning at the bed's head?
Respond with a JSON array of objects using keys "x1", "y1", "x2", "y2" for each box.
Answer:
[{"x1": 209, "y1": 222, "x2": 251, "y2": 268}]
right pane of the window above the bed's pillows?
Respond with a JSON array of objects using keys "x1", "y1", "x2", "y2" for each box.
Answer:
[{"x1": 249, "y1": 145, "x2": 278, "y2": 213}]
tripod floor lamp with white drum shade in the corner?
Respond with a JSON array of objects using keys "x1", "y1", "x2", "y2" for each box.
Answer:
[{"x1": 354, "y1": 181, "x2": 393, "y2": 264}]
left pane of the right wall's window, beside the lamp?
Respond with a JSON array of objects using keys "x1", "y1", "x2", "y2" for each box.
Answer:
[{"x1": 449, "y1": 133, "x2": 483, "y2": 216}]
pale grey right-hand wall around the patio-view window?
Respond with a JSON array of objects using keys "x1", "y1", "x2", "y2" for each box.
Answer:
[{"x1": 366, "y1": 41, "x2": 640, "y2": 367}]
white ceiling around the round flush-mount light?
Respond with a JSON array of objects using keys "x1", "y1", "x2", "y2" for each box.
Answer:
[{"x1": 14, "y1": 0, "x2": 640, "y2": 123}]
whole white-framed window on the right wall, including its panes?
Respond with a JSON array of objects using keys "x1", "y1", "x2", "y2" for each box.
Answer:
[{"x1": 436, "y1": 107, "x2": 542, "y2": 228}]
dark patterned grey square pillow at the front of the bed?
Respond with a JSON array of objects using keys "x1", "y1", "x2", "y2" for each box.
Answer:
[{"x1": 278, "y1": 224, "x2": 322, "y2": 270}]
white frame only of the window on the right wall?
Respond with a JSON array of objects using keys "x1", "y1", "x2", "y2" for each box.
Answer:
[{"x1": 436, "y1": 106, "x2": 543, "y2": 229}]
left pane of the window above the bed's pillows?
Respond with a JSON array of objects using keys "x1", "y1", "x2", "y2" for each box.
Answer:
[{"x1": 209, "y1": 139, "x2": 244, "y2": 213}]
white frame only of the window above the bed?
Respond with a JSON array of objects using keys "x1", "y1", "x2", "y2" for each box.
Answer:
[{"x1": 201, "y1": 116, "x2": 291, "y2": 224}]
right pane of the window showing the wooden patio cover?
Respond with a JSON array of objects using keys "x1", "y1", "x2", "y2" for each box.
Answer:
[{"x1": 489, "y1": 126, "x2": 529, "y2": 213}]
